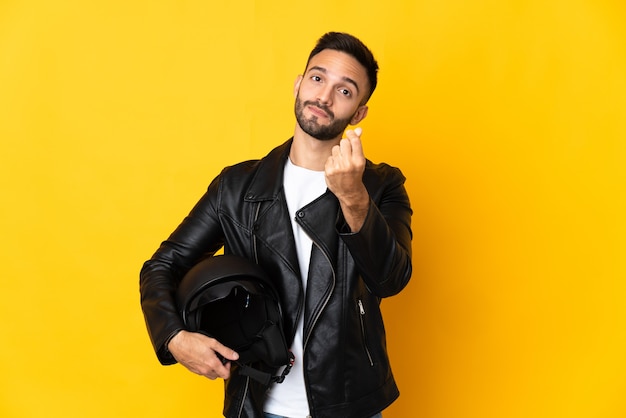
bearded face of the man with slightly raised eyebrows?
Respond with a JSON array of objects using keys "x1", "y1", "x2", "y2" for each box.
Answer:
[{"x1": 295, "y1": 49, "x2": 369, "y2": 141}]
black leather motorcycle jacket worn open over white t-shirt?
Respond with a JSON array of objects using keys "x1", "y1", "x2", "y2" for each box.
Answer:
[{"x1": 140, "y1": 140, "x2": 412, "y2": 418}]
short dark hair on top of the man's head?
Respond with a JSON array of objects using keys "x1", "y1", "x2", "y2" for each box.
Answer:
[{"x1": 306, "y1": 32, "x2": 378, "y2": 103}]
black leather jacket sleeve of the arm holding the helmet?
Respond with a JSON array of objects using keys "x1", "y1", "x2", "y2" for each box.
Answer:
[{"x1": 139, "y1": 177, "x2": 223, "y2": 364}]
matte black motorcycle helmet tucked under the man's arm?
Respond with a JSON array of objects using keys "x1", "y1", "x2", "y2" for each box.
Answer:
[{"x1": 176, "y1": 255, "x2": 294, "y2": 384}]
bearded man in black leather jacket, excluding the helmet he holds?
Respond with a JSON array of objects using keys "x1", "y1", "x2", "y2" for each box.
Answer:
[{"x1": 140, "y1": 32, "x2": 412, "y2": 418}]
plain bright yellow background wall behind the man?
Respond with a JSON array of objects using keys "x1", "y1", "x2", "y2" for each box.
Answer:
[{"x1": 0, "y1": 0, "x2": 626, "y2": 418}]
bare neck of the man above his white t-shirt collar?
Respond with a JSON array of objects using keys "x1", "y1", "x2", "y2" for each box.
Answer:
[{"x1": 289, "y1": 125, "x2": 341, "y2": 171}]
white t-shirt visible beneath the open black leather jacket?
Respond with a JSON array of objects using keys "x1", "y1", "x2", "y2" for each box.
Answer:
[{"x1": 264, "y1": 159, "x2": 326, "y2": 418}]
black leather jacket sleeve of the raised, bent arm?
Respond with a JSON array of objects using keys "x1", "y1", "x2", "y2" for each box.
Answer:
[{"x1": 340, "y1": 165, "x2": 413, "y2": 297}]
